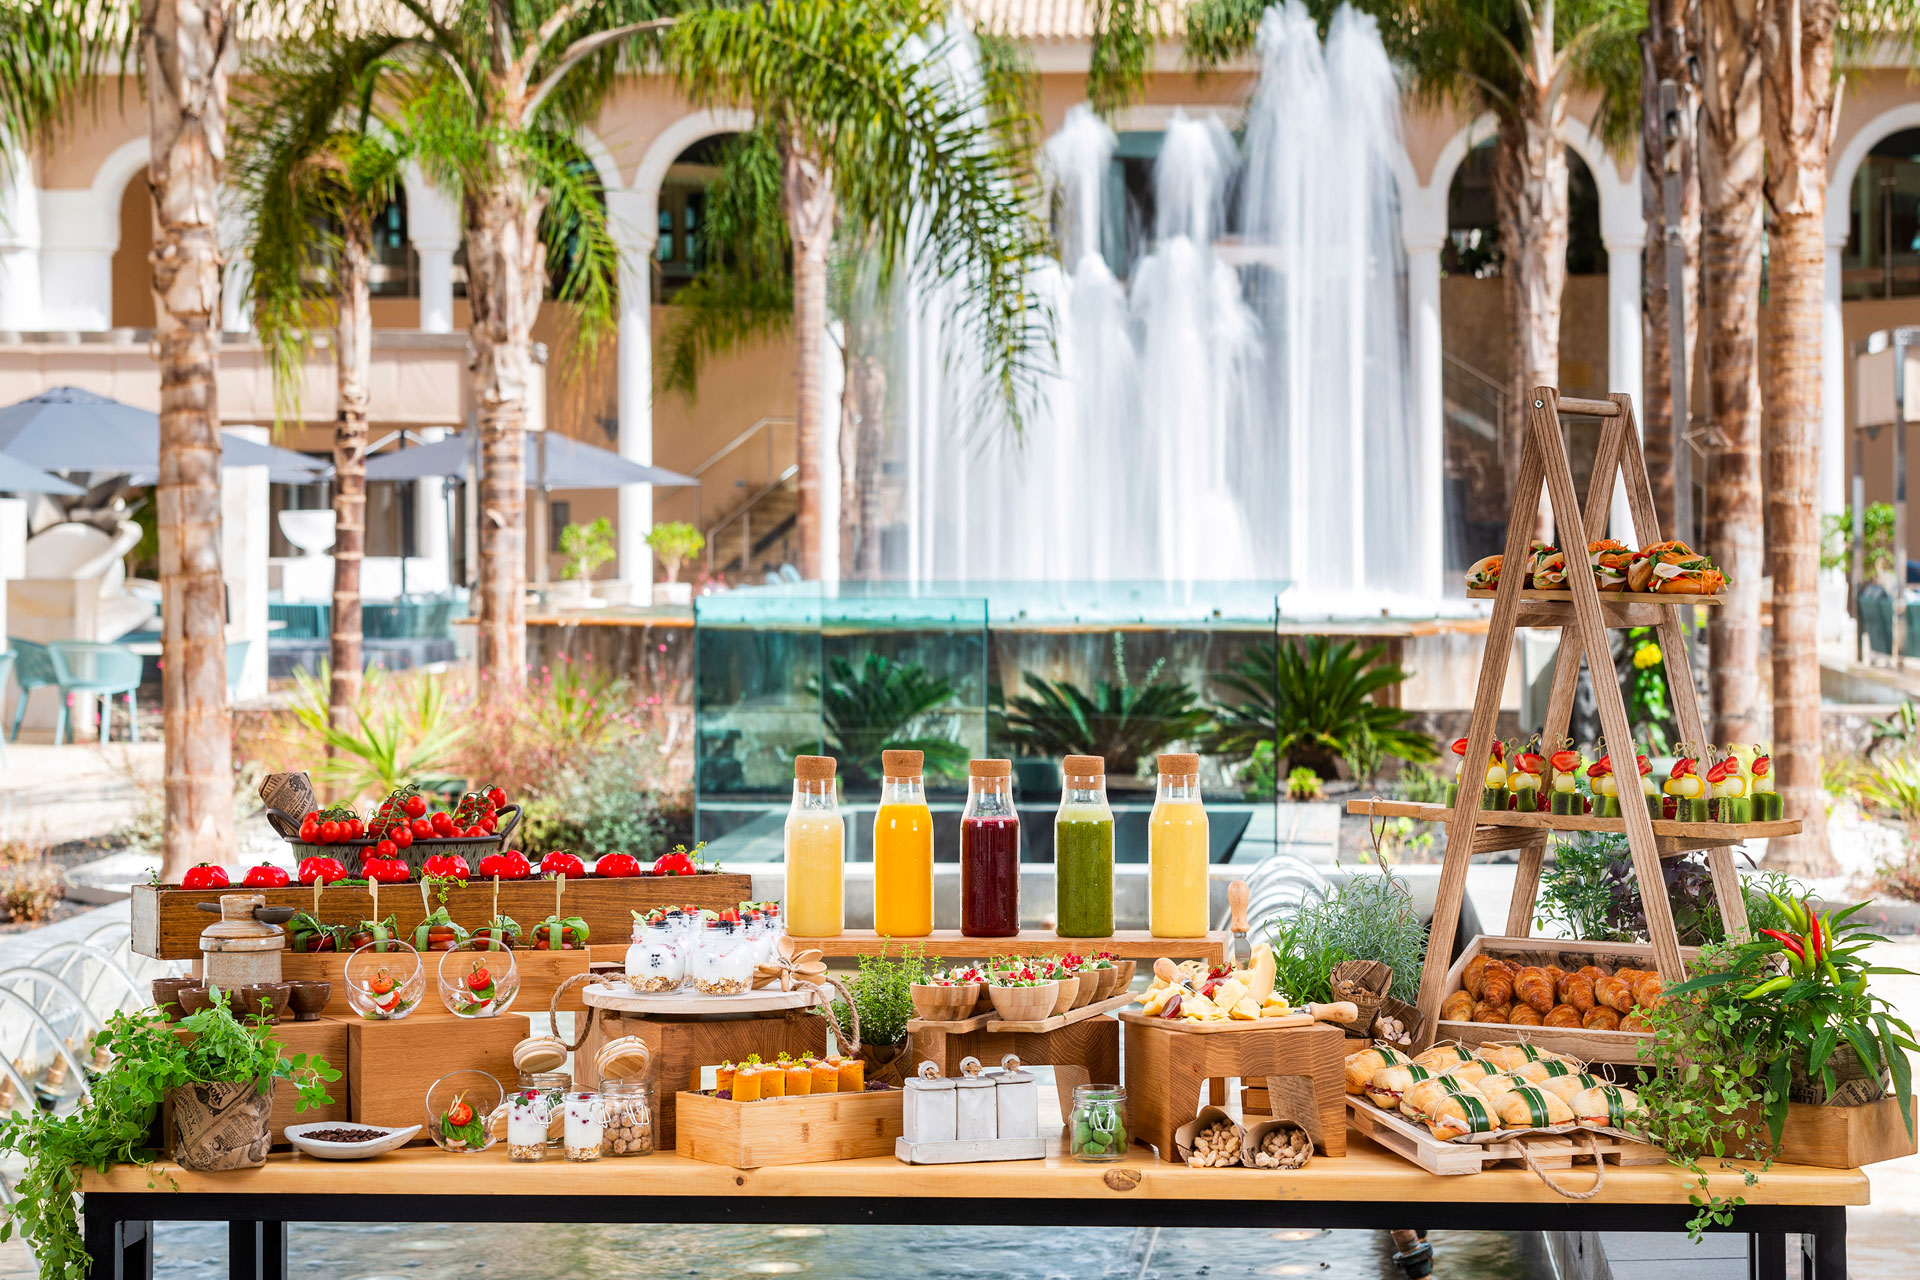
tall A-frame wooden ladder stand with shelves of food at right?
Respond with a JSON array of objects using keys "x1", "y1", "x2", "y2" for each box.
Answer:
[{"x1": 1348, "y1": 388, "x2": 1799, "y2": 1048}]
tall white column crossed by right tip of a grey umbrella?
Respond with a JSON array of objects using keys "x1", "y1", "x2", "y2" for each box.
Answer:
[{"x1": 607, "y1": 190, "x2": 659, "y2": 604}]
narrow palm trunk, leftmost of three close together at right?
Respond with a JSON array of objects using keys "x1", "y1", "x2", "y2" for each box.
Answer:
[{"x1": 1640, "y1": 0, "x2": 1699, "y2": 537}]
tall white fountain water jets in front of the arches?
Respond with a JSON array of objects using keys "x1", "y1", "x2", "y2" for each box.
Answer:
[{"x1": 887, "y1": 0, "x2": 1413, "y2": 612}]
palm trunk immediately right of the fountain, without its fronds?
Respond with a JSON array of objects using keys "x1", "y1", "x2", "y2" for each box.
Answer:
[{"x1": 1494, "y1": 105, "x2": 1578, "y2": 537}]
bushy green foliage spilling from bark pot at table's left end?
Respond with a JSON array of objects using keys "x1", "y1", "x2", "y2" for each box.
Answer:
[{"x1": 0, "y1": 992, "x2": 340, "y2": 1280}]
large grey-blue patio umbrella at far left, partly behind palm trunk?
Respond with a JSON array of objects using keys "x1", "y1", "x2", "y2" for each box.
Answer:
[{"x1": 0, "y1": 386, "x2": 328, "y2": 484}]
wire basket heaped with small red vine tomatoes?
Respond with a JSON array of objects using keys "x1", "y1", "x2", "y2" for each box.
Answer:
[{"x1": 267, "y1": 783, "x2": 520, "y2": 877}]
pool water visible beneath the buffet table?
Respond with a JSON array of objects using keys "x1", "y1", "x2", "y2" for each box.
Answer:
[{"x1": 131, "y1": 1201, "x2": 1551, "y2": 1280}]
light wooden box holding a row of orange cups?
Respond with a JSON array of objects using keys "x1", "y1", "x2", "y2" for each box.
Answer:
[{"x1": 674, "y1": 1088, "x2": 906, "y2": 1169}]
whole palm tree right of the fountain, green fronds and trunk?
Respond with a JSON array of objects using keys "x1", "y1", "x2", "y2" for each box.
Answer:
[{"x1": 1092, "y1": 0, "x2": 1645, "y2": 514}]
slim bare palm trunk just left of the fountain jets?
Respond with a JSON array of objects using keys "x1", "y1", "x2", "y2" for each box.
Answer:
[{"x1": 785, "y1": 134, "x2": 835, "y2": 578}]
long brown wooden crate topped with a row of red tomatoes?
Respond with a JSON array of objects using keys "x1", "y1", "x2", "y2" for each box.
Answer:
[{"x1": 132, "y1": 871, "x2": 753, "y2": 960}]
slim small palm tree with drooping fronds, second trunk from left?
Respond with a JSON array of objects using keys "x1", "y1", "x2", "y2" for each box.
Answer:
[{"x1": 234, "y1": 36, "x2": 405, "y2": 754}]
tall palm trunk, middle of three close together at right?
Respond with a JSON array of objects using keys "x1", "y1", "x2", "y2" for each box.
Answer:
[{"x1": 1704, "y1": 0, "x2": 1758, "y2": 743}]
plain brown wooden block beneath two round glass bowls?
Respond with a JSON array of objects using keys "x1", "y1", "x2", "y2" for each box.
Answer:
[{"x1": 348, "y1": 1013, "x2": 528, "y2": 1140}]
